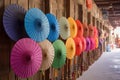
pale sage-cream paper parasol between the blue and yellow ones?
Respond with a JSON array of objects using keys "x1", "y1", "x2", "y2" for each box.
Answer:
[{"x1": 59, "y1": 17, "x2": 70, "y2": 40}]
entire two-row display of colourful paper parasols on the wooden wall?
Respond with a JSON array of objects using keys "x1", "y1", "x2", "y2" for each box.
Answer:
[{"x1": 3, "y1": 4, "x2": 103, "y2": 78}]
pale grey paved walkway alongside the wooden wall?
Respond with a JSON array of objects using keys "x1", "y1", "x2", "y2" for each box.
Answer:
[{"x1": 77, "y1": 49, "x2": 120, "y2": 80}]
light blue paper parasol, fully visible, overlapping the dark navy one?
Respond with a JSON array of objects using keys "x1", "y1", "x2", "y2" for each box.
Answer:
[{"x1": 25, "y1": 8, "x2": 50, "y2": 42}]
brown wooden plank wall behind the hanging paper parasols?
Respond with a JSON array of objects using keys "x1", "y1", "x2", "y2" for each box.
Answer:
[{"x1": 0, "y1": 0, "x2": 107, "y2": 80}]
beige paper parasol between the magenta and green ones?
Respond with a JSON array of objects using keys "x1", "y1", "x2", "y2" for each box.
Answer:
[{"x1": 39, "y1": 40, "x2": 54, "y2": 70}]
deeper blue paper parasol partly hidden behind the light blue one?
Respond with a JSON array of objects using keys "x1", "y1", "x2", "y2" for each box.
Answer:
[{"x1": 46, "y1": 13, "x2": 59, "y2": 42}]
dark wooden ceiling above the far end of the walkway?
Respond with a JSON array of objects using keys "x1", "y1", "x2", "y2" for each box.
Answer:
[{"x1": 94, "y1": 0, "x2": 120, "y2": 28}]
